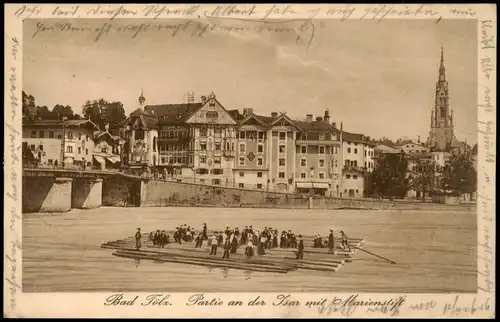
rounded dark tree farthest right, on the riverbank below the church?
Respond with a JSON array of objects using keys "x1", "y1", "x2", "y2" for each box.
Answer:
[{"x1": 442, "y1": 154, "x2": 477, "y2": 193}]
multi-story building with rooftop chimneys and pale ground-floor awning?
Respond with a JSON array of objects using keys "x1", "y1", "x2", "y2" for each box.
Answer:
[{"x1": 295, "y1": 110, "x2": 342, "y2": 197}]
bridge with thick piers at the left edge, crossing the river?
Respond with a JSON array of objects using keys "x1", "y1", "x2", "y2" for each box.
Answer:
[{"x1": 22, "y1": 165, "x2": 153, "y2": 212}]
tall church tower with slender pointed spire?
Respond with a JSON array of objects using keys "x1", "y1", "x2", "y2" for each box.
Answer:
[{"x1": 427, "y1": 47, "x2": 455, "y2": 151}]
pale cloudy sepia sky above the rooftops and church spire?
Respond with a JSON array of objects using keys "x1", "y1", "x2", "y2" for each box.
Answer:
[{"x1": 23, "y1": 18, "x2": 477, "y2": 144}]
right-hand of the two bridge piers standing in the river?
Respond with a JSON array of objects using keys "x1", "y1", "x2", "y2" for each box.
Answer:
[{"x1": 71, "y1": 178, "x2": 102, "y2": 209}]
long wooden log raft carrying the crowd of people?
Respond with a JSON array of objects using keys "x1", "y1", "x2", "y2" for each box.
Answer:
[{"x1": 101, "y1": 232, "x2": 364, "y2": 274}]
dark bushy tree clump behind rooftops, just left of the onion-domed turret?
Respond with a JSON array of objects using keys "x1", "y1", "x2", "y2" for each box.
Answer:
[{"x1": 83, "y1": 98, "x2": 126, "y2": 129}]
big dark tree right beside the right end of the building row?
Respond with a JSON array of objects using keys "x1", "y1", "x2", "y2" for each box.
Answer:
[{"x1": 368, "y1": 153, "x2": 408, "y2": 197}]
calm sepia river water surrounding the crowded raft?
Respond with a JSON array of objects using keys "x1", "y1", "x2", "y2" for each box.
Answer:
[{"x1": 23, "y1": 207, "x2": 477, "y2": 293}]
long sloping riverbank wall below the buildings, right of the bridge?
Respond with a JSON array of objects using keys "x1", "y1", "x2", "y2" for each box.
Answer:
[{"x1": 139, "y1": 180, "x2": 476, "y2": 211}]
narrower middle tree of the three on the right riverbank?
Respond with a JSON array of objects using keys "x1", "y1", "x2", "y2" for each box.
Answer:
[{"x1": 409, "y1": 158, "x2": 438, "y2": 200}]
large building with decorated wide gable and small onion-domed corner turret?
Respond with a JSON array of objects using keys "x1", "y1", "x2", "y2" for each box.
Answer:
[{"x1": 126, "y1": 92, "x2": 236, "y2": 185}]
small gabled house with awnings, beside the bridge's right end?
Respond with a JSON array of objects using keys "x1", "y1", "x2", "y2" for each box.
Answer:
[{"x1": 93, "y1": 125, "x2": 125, "y2": 170}]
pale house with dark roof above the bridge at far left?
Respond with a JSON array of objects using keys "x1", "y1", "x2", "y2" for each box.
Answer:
[{"x1": 23, "y1": 120, "x2": 99, "y2": 168}]
